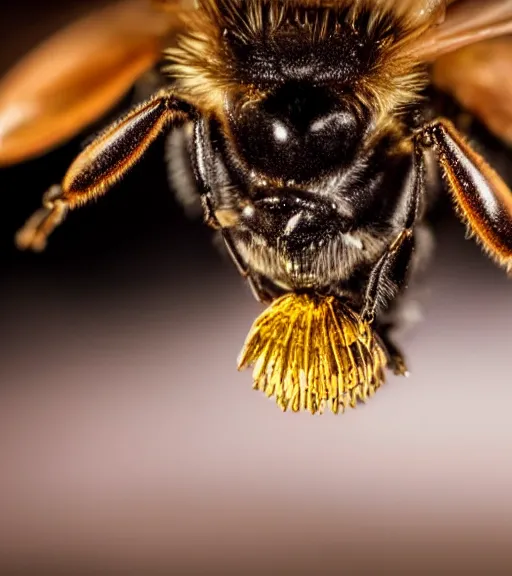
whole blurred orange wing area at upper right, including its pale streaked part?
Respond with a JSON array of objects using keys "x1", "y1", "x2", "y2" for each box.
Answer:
[{"x1": 411, "y1": 0, "x2": 512, "y2": 142}]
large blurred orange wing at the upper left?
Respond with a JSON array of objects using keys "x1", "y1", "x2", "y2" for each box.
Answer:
[{"x1": 0, "y1": 0, "x2": 191, "y2": 165}]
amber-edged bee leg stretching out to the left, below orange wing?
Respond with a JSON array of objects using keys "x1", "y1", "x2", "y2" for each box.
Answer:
[{"x1": 16, "y1": 92, "x2": 193, "y2": 251}]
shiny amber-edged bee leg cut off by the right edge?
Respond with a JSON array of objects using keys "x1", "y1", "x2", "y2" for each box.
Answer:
[{"x1": 419, "y1": 119, "x2": 512, "y2": 274}]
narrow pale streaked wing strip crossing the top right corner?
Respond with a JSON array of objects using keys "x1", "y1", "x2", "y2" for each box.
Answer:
[{"x1": 409, "y1": 0, "x2": 512, "y2": 62}]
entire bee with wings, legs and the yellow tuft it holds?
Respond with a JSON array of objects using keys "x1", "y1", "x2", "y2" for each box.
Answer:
[{"x1": 0, "y1": 0, "x2": 512, "y2": 413}]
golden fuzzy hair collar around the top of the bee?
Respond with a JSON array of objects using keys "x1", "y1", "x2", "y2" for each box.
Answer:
[{"x1": 165, "y1": 0, "x2": 444, "y2": 119}]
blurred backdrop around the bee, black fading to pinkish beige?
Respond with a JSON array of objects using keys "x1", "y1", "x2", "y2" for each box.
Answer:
[{"x1": 0, "y1": 0, "x2": 512, "y2": 576}]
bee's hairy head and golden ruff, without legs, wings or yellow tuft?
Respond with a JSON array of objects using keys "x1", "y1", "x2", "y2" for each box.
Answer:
[{"x1": 169, "y1": 0, "x2": 432, "y2": 291}]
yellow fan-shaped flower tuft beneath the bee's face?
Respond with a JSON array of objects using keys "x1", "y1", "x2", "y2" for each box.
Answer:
[{"x1": 238, "y1": 294, "x2": 387, "y2": 414}]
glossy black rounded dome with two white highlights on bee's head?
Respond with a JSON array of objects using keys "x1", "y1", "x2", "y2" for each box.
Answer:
[{"x1": 231, "y1": 85, "x2": 361, "y2": 181}]
